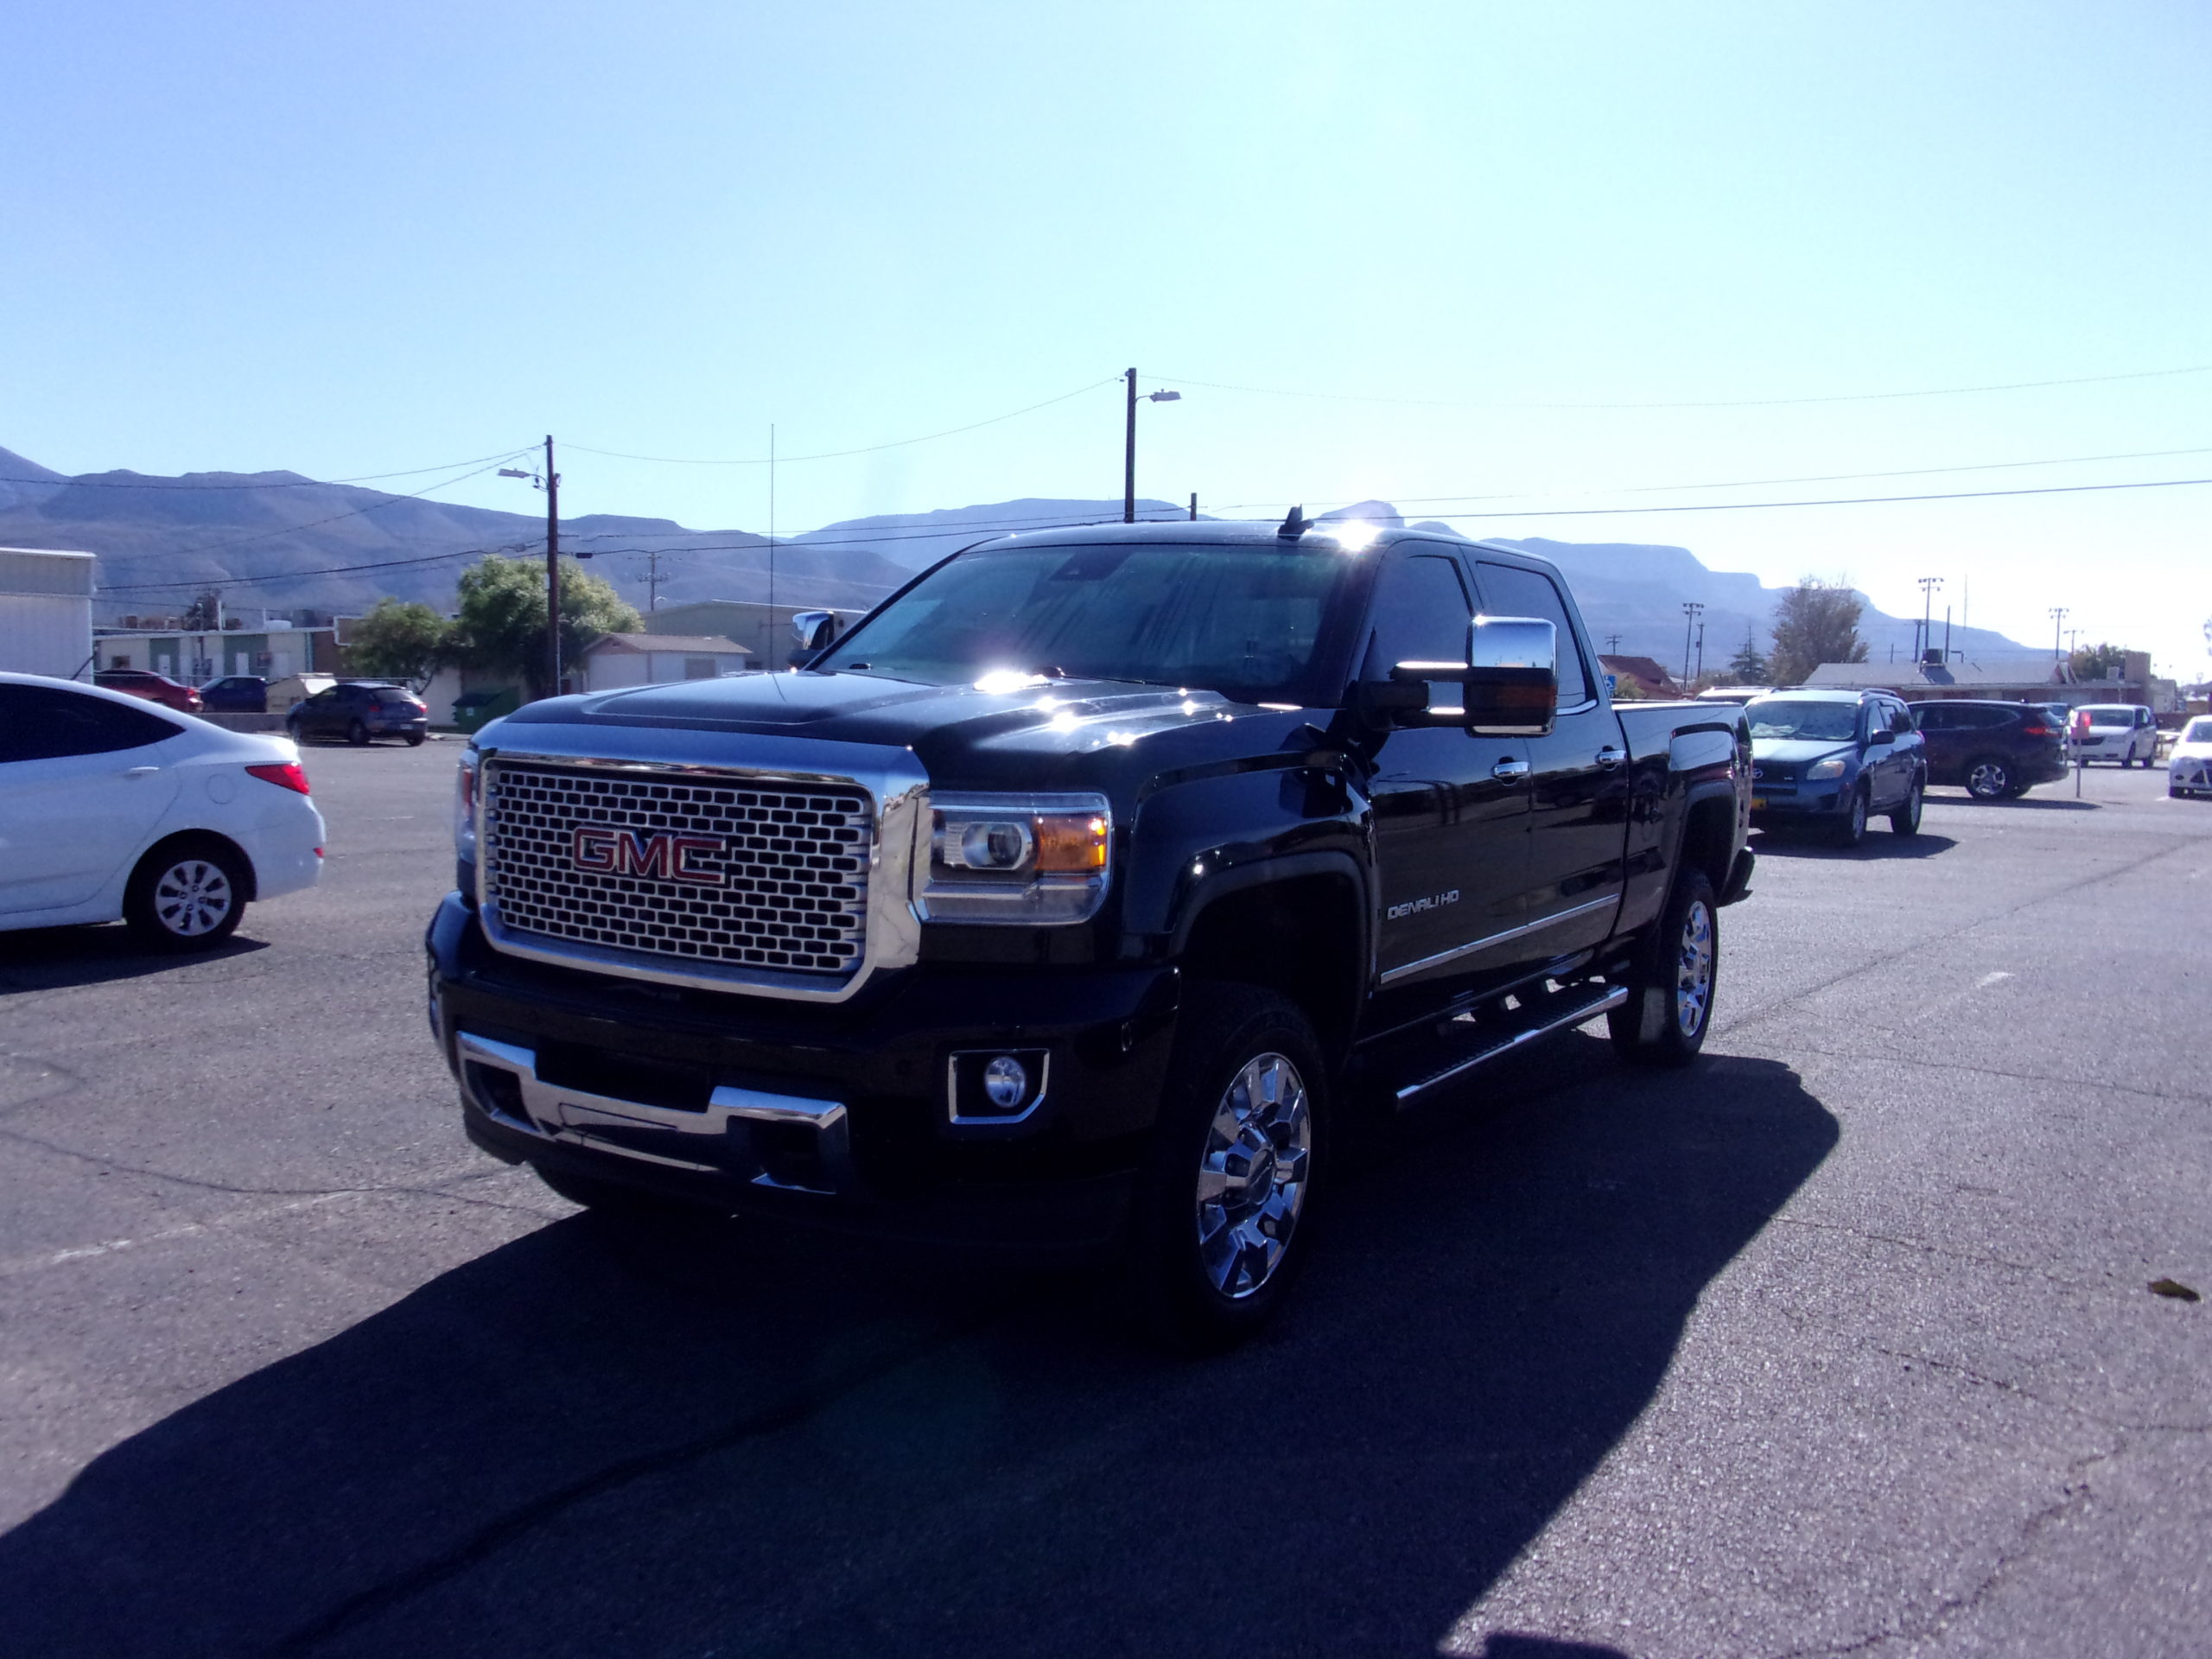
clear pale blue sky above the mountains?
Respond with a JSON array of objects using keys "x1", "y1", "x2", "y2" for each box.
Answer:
[{"x1": 0, "y1": 0, "x2": 2212, "y2": 675}]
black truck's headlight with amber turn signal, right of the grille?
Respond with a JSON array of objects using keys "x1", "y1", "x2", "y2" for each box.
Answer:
[{"x1": 916, "y1": 794, "x2": 1113, "y2": 923}]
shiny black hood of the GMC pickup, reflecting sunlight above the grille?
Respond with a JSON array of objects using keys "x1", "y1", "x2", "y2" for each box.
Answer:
[{"x1": 480, "y1": 672, "x2": 1330, "y2": 787}]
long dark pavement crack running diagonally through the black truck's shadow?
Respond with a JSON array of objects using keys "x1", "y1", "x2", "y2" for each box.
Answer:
[{"x1": 265, "y1": 1312, "x2": 1000, "y2": 1659}]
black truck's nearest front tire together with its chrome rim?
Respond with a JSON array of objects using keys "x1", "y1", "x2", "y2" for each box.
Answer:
[{"x1": 1128, "y1": 980, "x2": 1330, "y2": 1350}]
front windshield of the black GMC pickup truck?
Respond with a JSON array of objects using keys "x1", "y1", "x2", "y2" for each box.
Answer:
[{"x1": 814, "y1": 544, "x2": 1360, "y2": 706}]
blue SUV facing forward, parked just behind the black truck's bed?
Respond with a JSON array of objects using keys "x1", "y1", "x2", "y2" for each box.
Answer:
[{"x1": 1743, "y1": 690, "x2": 1927, "y2": 847}]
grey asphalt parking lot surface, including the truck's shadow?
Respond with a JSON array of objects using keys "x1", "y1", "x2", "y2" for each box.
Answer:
[{"x1": 0, "y1": 743, "x2": 2212, "y2": 1659}]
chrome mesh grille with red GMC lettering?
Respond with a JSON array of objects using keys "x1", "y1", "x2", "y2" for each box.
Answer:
[{"x1": 478, "y1": 759, "x2": 874, "y2": 976}]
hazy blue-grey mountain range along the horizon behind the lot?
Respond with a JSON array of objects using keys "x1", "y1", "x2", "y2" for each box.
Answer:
[{"x1": 0, "y1": 449, "x2": 2035, "y2": 672}]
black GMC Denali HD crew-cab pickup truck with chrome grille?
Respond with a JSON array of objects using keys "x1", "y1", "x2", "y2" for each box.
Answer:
[{"x1": 427, "y1": 526, "x2": 1752, "y2": 1340}]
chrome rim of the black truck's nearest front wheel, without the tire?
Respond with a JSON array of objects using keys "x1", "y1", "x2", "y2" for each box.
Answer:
[{"x1": 1197, "y1": 1053, "x2": 1314, "y2": 1300}]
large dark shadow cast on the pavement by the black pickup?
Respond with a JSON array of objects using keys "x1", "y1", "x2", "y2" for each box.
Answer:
[{"x1": 0, "y1": 1035, "x2": 1838, "y2": 1659}]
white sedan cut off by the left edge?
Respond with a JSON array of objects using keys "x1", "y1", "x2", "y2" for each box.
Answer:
[{"x1": 0, "y1": 675, "x2": 323, "y2": 951}]
